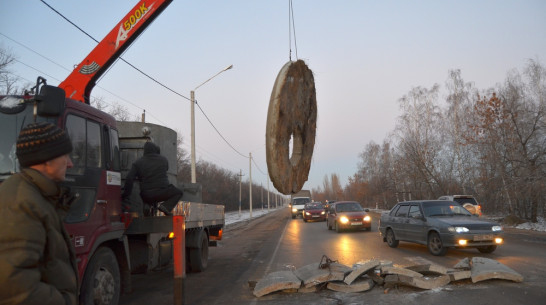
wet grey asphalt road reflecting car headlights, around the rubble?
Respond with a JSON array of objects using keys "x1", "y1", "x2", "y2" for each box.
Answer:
[{"x1": 120, "y1": 209, "x2": 546, "y2": 305}]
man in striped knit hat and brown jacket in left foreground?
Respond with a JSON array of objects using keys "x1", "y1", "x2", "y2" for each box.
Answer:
[{"x1": 0, "y1": 122, "x2": 78, "y2": 305}]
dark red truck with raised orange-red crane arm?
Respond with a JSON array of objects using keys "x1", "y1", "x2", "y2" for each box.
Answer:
[{"x1": 0, "y1": 0, "x2": 225, "y2": 305}]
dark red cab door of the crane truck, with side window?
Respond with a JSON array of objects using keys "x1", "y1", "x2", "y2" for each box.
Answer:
[{"x1": 65, "y1": 113, "x2": 123, "y2": 255}]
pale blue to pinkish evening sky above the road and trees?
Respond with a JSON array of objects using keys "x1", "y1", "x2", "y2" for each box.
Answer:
[{"x1": 0, "y1": 0, "x2": 546, "y2": 189}]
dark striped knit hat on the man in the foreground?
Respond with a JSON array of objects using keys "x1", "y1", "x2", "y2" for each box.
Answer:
[{"x1": 15, "y1": 122, "x2": 72, "y2": 167}]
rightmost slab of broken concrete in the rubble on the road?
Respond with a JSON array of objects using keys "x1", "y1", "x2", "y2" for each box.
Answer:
[{"x1": 470, "y1": 257, "x2": 523, "y2": 283}]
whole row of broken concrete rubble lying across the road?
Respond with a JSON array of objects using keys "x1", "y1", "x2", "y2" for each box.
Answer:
[{"x1": 253, "y1": 257, "x2": 523, "y2": 297}]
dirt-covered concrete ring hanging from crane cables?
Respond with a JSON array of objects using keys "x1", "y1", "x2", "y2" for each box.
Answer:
[{"x1": 265, "y1": 60, "x2": 317, "y2": 195}]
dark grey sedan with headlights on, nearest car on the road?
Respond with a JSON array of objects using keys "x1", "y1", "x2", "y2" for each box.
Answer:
[{"x1": 379, "y1": 200, "x2": 504, "y2": 256}]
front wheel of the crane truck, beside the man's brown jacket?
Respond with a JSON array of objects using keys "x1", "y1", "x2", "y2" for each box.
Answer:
[{"x1": 80, "y1": 247, "x2": 121, "y2": 305}]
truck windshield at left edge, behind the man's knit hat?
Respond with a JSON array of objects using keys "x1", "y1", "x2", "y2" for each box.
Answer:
[{"x1": 0, "y1": 97, "x2": 53, "y2": 181}]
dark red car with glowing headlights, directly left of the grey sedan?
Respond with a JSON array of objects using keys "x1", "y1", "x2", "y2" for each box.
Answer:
[{"x1": 326, "y1": 201, "x2": 372, "y2": 233}]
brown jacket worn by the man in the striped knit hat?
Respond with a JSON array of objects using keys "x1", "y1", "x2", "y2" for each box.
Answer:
[{"x1": 0, "y1": 168, "x2": 78, "y2": 305}]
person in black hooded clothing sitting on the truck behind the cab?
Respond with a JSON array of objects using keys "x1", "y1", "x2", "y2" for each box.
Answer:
[{"x1": 122, "y1": 142, "x2": 183, "y2": 215}]
